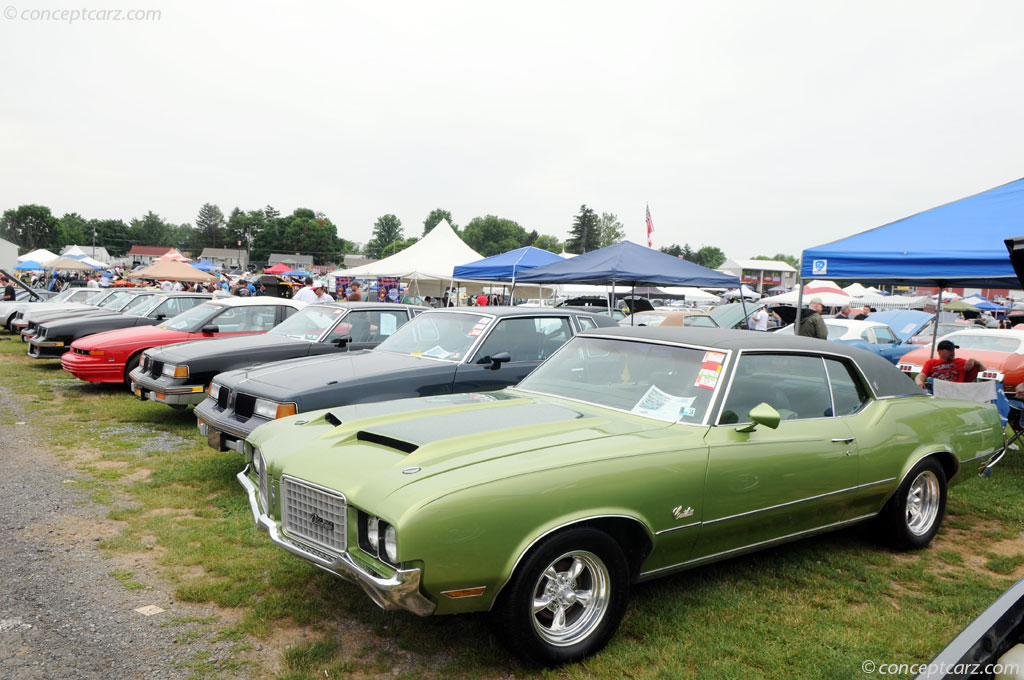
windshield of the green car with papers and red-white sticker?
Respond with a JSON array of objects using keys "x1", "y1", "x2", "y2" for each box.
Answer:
[{"x1": 518, "y1": 336, "x2": 726, "y2": 423}]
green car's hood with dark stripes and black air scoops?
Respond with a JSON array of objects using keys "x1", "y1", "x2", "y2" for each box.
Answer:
[{"x1": 250, "y1": 390, "x2": 679, "y2": 509}]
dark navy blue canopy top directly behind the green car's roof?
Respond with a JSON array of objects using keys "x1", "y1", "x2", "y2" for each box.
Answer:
[{"x1": 516, "y1": 241, "x2": 741, "y2": 288}]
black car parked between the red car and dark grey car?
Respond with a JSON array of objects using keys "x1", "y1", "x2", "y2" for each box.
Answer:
[{"x1": 131, "y1": 302, "x2": 426, "y2": 406}]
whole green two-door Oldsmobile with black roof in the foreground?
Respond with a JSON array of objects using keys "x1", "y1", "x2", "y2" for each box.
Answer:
[{"x1": 239, "y1": 327, "x2": 1004, "y2": 665}]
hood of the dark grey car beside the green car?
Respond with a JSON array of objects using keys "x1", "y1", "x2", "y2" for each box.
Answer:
[{"x1": 217, "y1": 350, "x2": 436, "y2": 394}]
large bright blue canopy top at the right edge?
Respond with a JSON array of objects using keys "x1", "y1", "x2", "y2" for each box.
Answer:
[{"x1": 800, "y1": 178, "x2": 1024, "y2": 288}]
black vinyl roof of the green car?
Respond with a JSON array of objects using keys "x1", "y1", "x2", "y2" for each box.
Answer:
[{"x1": 585, "y1": 326, "x2": 926, "y2": 397}]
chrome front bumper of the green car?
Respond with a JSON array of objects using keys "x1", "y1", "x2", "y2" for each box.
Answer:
[{"x1": 236, "y1": 465, "x2": 437, "y2": 617}]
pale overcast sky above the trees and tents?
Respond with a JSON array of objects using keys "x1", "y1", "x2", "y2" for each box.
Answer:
[{"x1": 0, "y1": 0, "x2": 1024, "y2": 257}]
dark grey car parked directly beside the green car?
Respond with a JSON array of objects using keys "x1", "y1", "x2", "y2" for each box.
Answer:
[{"x1": 196, "y1": 306, "x2": 615, "y2": 453}]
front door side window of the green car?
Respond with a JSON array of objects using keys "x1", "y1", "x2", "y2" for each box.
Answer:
[{"x1": 719, "y1": 354, "x2": 831, "y2": 425}]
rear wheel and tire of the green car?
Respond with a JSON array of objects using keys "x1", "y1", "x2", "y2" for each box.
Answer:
[{"x1": 883, "y1": 458, "x2": 946, "y2": 550}]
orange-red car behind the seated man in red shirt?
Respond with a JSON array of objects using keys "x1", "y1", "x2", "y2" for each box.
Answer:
[{"x1": 897, "y1": 328, "x2": 1024, "y2": 393}]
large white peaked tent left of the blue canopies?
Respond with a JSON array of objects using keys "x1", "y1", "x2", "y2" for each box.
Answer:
[{"x1": 328, "y1": 219, "x2": 483, "y2": 281}]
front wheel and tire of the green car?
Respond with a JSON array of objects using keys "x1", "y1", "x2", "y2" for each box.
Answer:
[{"x1": 495, "y1": 527, "x2": 629, "y2": 666}]
